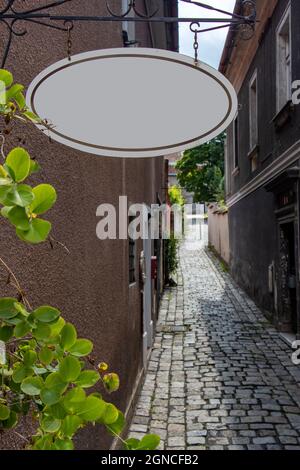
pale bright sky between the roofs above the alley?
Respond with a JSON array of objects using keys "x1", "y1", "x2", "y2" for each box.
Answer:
[{"x1": 179, "y1": 0, "x2": 235, "y2": 68}]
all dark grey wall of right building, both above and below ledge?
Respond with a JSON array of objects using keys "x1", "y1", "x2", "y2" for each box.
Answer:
[{"x1": 228, "y1": 0, "x2": 300, "y2": 312}]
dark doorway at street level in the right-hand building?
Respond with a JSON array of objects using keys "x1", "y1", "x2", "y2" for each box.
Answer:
[{"x1": 280, "y1": 222, "x2": 297, "y2": 334}]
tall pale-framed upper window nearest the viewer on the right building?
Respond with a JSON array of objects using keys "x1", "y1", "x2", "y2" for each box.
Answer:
[{"x1": 276, "y1": 7, "x2": 292, "y2": 112}]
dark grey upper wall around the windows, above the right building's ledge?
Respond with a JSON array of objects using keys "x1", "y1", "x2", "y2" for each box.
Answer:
[{"x1": 228, "y1": 0, "x2": 300, "y2": 195}]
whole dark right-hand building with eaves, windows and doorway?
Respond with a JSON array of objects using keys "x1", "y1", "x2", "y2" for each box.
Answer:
[{"x1": 220, "y1": 0, "x2": 300, "y2": 338}]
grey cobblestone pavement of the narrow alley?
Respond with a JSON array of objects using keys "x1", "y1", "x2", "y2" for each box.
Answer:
[{"x1": 130, "y1": 239, "x2": 300, "y2": 450}]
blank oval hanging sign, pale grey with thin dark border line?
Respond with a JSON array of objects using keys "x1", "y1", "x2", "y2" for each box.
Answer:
[{"x1": 27, "y1": 48, "x2": 237, "y2": 158}]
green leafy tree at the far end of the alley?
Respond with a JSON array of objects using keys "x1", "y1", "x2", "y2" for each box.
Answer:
[{"x1": 176, "y1": 134, "x2": 225, "y2": 202}]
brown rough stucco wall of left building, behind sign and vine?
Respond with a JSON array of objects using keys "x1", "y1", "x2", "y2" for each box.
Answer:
[{"x1": 0, "y1": 0, "x2": 168, "y2": 449}]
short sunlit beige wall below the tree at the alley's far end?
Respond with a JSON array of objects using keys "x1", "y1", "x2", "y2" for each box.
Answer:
[{"x1": 208, "y1": 205, "x2": 230, "y2": 264}]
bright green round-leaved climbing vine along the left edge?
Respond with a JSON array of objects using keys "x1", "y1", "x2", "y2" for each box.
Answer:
[{"x1": 0, "y1": 70, "x2": 160, "y2": 450}]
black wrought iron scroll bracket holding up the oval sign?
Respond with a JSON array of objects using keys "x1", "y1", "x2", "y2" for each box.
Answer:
[{"x1": 0, "y1": 0, "x2": 257, "y2": 68}]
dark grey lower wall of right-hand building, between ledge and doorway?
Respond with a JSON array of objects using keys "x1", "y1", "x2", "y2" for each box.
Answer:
[{"x1": 229, "y1": 188, "x2": 277, "y2": 312}]
